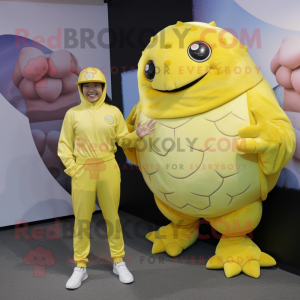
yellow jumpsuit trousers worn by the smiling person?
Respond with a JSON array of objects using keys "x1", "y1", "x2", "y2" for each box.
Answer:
[{"x1": 72, "y1": 158, "x2": 125, "y2": 268}]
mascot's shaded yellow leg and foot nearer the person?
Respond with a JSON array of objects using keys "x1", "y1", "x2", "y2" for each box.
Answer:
[{"x1": 146, "y1": 196, "x2": 199, "y2": 257}]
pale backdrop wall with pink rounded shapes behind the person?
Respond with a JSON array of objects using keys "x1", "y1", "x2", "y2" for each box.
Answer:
[{"x1": 0, "y1": 0, "x2": 111, "y2": 226}]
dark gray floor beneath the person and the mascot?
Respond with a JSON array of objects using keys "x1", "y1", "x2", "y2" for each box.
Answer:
[{"x1": 0, "y1": 212, "x2": 300, "y2": 300}]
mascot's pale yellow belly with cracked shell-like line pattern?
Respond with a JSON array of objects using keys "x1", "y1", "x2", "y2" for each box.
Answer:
[{"x1": 138, "y1": 94, "x2": 260, "y2": 218}]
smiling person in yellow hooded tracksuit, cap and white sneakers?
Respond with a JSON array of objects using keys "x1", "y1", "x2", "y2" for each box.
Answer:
[{"x1": 58, "y1": 68, "x2": 155, "y2": 289}]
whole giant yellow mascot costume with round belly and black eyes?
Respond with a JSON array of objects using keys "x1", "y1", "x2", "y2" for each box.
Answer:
[{"x1": 124, "y1": 22, "x2": 295, "y2": 278}]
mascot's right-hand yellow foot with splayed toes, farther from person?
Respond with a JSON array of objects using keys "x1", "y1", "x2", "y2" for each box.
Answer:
[{"x1": 206, "y1": 236, "x2": 276, "y2": 278}]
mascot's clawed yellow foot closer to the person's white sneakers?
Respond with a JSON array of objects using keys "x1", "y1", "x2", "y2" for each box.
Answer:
[{"x1": 146, "y1": 222, "x2": 198, "y2": 257}]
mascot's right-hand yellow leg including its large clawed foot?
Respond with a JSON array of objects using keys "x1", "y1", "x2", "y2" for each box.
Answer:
[{"x1": 206, "y1": 199, "x2": 276, "y2": 278}]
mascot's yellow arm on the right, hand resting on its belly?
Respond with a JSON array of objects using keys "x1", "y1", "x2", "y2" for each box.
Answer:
[{"x1": 236, "y1": 79, "x2": 296, "y2": 175}]
